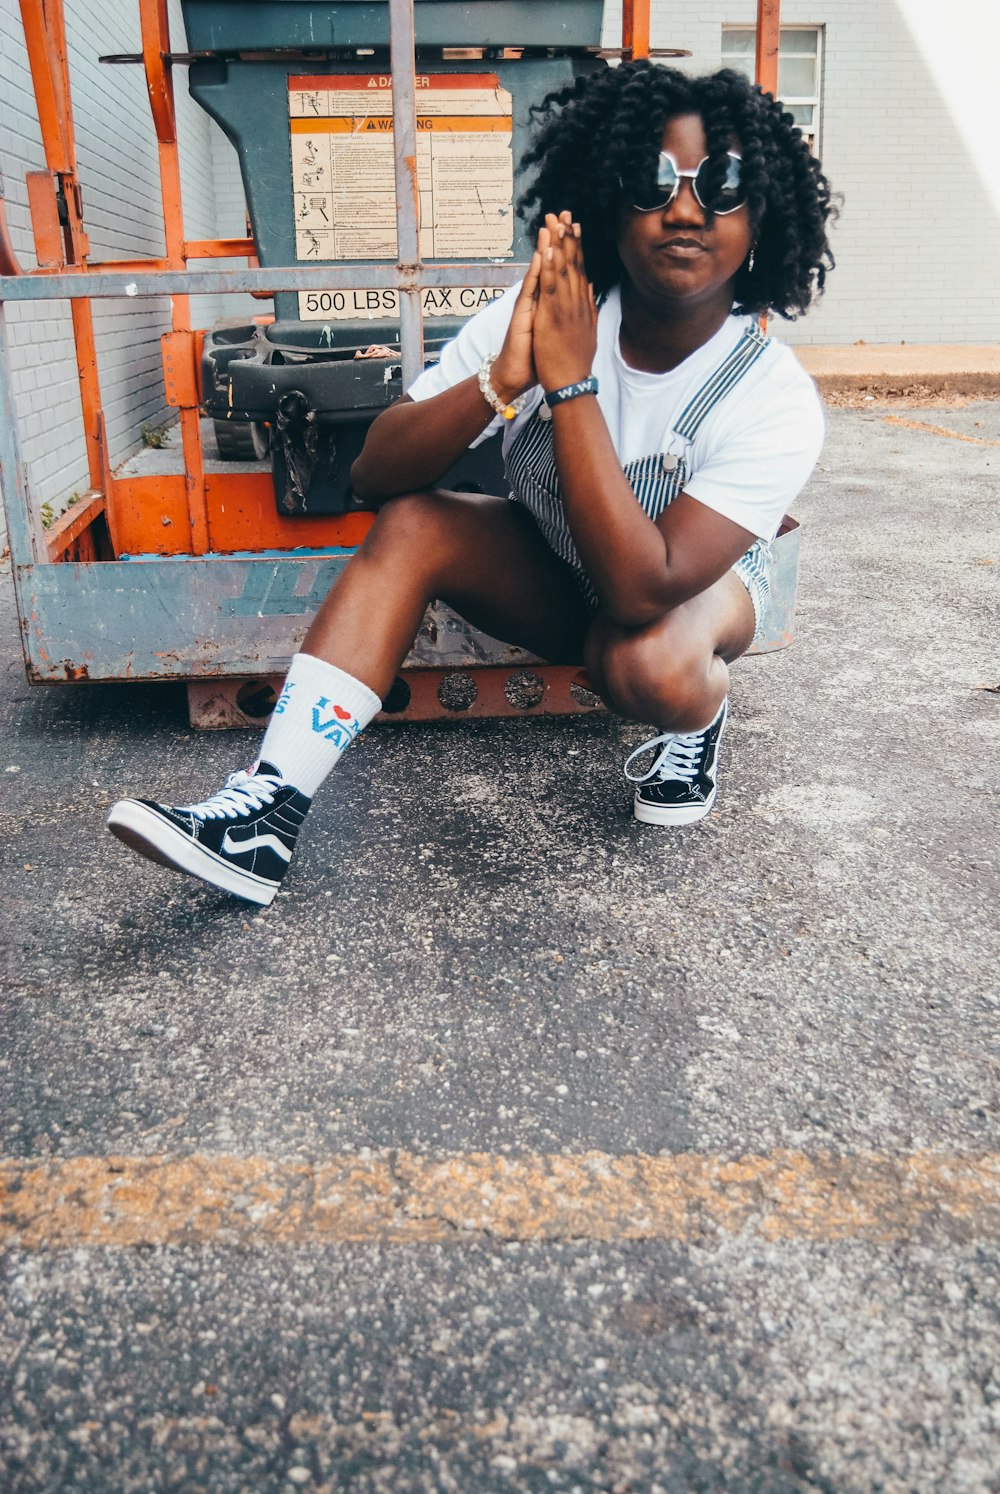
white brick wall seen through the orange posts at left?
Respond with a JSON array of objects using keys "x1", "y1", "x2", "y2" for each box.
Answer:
[{"x1": 0, "y1": 0, "x2": 237, "y2": 525}]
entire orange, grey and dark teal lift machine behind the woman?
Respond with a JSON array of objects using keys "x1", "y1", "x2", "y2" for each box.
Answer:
[{"x1": 0, "y1": 0, "x2": 798, "y2": 726}]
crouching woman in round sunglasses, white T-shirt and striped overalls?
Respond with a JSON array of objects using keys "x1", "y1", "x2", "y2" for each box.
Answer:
[{"x1": 108, "y1": 61, "x2": 833, "y2": 904}]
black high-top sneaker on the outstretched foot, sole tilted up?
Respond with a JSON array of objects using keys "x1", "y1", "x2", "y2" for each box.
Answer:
[{"x1": 108, "y1": 762, "x2": 312, "y2": 907}]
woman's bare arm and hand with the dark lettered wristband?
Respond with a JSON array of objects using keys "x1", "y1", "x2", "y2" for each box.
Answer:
[{"x1": 534, "y1": 217, "x2": 756, "y2": 627}]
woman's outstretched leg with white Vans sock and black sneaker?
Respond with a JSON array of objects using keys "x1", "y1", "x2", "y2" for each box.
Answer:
[{"x1": 108, "y1": 492, "x2": 587, "y2": 907}]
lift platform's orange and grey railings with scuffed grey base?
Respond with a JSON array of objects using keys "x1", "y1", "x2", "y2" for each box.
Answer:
[{"x1": 0, "y1": 0, "x2": 800, "y2": 726}]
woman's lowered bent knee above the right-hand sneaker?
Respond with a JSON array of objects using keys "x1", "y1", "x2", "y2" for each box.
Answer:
[{"x1": 595, "y1": 624, "x2": 708, "y2": 731}]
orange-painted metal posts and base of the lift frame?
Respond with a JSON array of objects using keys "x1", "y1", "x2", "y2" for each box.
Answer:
[{"x1": 0, "y1": 0, "x2": 780, "y2": 560}]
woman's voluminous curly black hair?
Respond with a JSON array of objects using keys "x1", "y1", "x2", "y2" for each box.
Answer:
[{"x1": 517, "y1": 60, "x2": 836, "y2": 320}]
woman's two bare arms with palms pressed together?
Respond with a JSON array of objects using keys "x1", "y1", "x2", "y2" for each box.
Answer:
[{"x1": 351, "y1": 200, "x2": 741, "y2": 636}]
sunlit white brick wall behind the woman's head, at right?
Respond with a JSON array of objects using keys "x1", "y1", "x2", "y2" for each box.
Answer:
[{"x1": 605, "y1": 0, "x2": 1000, "y2": 344}]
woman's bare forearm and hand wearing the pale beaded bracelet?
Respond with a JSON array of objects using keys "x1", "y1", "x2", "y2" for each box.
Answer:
[{"x1": 351, "y1": 252, "x2": 541, "y2": 502}]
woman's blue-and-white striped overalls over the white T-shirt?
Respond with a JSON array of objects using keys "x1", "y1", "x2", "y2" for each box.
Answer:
[{"x1": 507, "y1": 327, "x2": 771, "y2": 630}]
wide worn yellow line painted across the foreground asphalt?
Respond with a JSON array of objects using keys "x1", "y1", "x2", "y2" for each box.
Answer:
[{"x1": 0, "y1": 1152, "x2": 1000, "y2": 1249}]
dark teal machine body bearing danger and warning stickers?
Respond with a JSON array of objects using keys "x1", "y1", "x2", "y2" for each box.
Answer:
[{"x1": 182, "y1": 0, "x2": 607, "y2": 514}]
